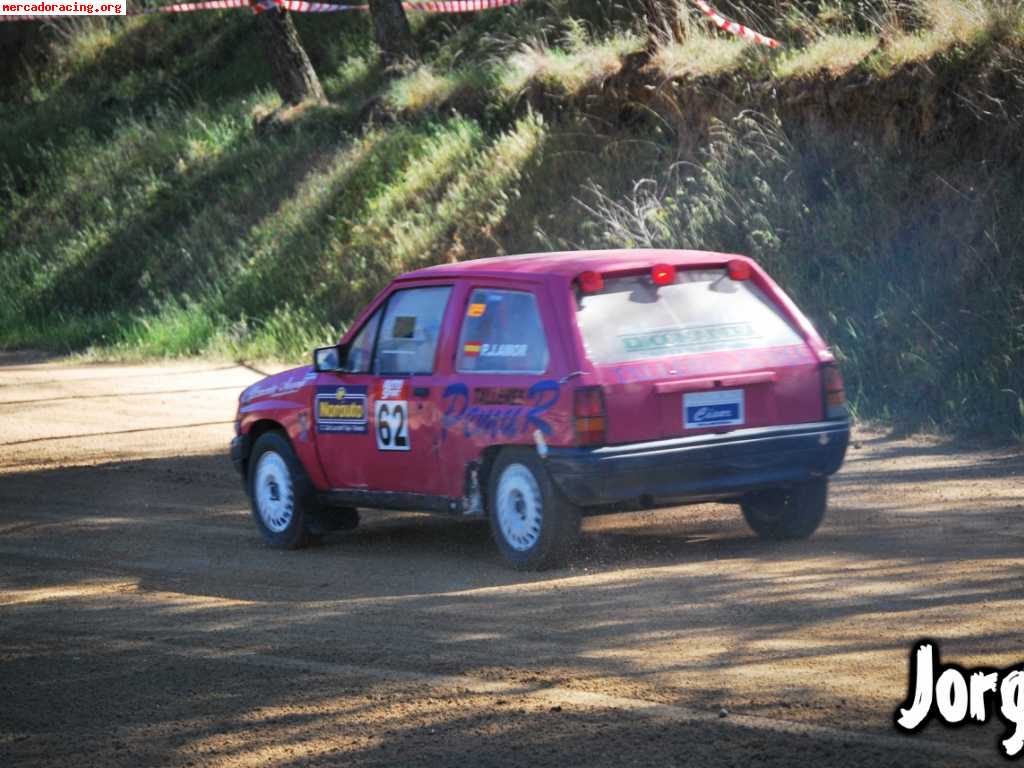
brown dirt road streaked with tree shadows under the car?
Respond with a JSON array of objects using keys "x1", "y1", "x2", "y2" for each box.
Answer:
[{"x1": 0, "y1": 355, "x2": 1024, "y2": 767}]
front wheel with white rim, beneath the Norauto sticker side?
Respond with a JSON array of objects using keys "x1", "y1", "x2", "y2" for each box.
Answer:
[{"x1": 248, "y1": 432, "x2": 323, "y2": 549}]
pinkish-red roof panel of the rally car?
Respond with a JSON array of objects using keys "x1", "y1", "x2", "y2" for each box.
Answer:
[{"x1": 398, "y1": 248, "x2": 743, "y2": 281}]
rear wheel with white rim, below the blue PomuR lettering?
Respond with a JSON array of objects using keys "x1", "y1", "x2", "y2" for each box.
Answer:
[{"x1": 487, "y1": 449, "x2": 580, "y2": 570}]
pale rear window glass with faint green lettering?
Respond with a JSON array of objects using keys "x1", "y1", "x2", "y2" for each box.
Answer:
[{"x1": 577, "y1": 269, "x2": 803, "y2": 365}]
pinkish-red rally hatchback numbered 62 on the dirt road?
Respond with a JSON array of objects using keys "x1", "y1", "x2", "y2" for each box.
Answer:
[{"x1": 231, "y1": 250, "x2": 849, "y2": 568}]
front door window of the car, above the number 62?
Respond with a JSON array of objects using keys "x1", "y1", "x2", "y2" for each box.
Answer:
[{"x1": 374, "y1": 286, "x2": 452, "y2": 374}]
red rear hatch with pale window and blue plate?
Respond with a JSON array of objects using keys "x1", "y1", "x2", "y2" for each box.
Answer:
[{"x1": 573, "y1": 259, "x2": 823, "y2": 444}]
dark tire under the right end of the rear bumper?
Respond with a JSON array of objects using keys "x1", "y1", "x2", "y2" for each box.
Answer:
[{"x1": 739, "y1": 477, "x2": 828, "y2": 541}]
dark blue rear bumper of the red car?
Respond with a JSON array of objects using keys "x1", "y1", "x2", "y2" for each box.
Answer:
[{"x1": 547, "y1": 421, "x2": 850, "y2": 506}]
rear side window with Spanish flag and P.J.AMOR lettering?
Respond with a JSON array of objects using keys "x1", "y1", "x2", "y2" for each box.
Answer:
[{"x1": 456, "y1": 288, "x2": 550, "y2": 374}]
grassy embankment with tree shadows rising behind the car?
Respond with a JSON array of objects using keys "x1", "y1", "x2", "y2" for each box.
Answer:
[{"x1": 0, "y1": 0, "x2": 1024, "y2": 439}]
